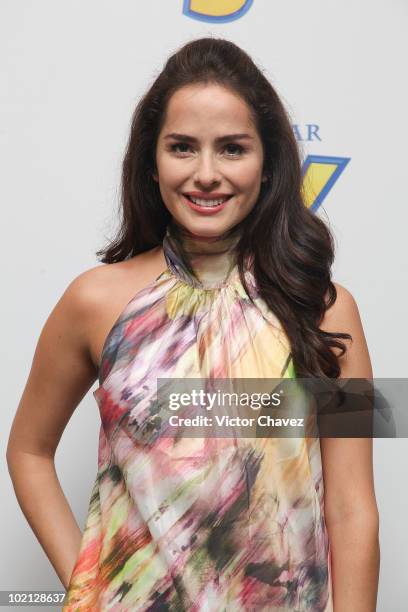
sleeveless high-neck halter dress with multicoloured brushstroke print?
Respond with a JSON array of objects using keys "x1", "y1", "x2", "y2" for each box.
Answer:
[{"x1": 62, "y1": 219, "x2": 333, "y2": 612}]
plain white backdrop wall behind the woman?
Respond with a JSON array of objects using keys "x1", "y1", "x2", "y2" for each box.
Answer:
[{"x1": 0, "y1": 0, "x2": 408, "y2": 612}]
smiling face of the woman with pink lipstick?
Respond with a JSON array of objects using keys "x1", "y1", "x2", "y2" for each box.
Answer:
[{"x1": 153, "y1": 84, "x2": 266, "y2": 237}]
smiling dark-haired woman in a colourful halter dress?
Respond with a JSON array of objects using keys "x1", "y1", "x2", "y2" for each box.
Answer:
[{"x1": 8, "y1": 38, "x2": 379, "y2": 612}]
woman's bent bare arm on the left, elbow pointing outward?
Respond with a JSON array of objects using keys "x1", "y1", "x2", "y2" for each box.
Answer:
[{"x1": 7, "y1": 271, "x2": 97, "y2": 588}]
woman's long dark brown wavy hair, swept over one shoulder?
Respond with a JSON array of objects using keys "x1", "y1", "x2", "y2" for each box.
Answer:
[{"x1": 96, "y1": 37, "x2": 351, "y2": 378}]
